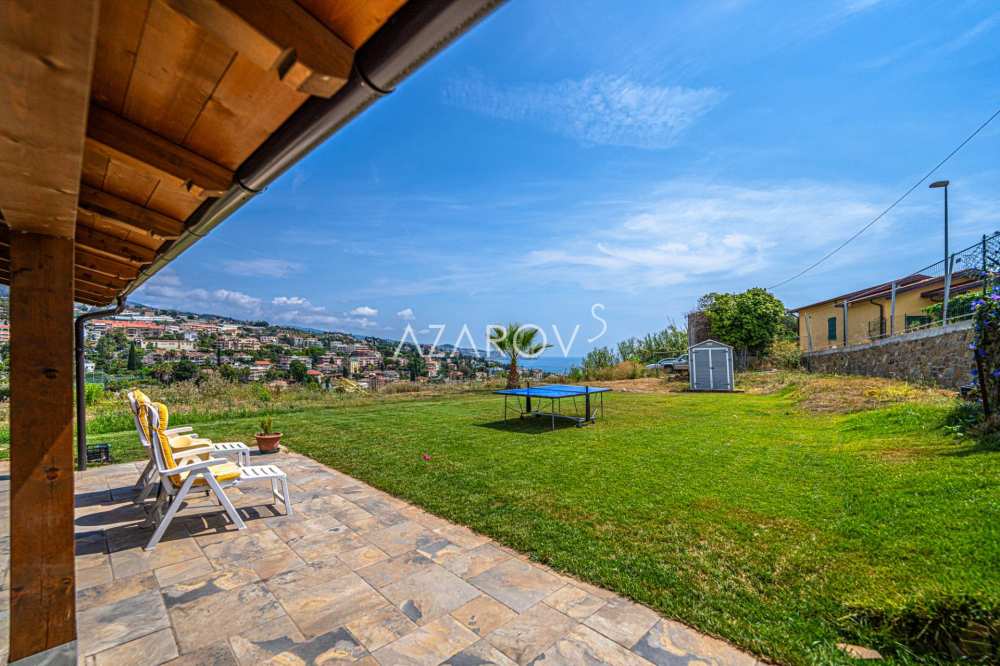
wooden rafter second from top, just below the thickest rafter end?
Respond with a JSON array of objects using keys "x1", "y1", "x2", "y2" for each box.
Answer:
[{"x1": 87, "y1": 104, "x2": 233, "y2": 197}]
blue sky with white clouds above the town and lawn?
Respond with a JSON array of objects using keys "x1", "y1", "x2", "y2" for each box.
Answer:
[{"x1": 133, "y1": 0, "x2": 1000, "y2": 355}]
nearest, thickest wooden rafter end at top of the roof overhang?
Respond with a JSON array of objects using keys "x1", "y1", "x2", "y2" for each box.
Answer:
[{"x1": 165, "y1": 0, "x2": 354, "y2": 97}]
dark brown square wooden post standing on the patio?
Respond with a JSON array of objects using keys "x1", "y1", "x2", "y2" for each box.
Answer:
[{"x1": 10, "y1": 232, "x2": 76, "y2": 661}]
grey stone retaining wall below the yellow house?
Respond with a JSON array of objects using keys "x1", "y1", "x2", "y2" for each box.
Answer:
[{"x1": 802, "y1": 320, "x2": 975, "y2": 389}]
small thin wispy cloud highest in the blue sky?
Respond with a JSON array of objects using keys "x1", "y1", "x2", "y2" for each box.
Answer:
[{"x1": 446, "y1": 74, "x2": 724, "y2": 149}]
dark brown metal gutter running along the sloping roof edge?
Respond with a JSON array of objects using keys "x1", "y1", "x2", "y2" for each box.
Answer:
[{"x1": 125, "y1": 0, "x2": 504, "y2": 294}]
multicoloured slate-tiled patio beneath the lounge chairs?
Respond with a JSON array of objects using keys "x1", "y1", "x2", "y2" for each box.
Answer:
[{"x1": 0, "y1": 454, "x2": 757, "y2": 666}]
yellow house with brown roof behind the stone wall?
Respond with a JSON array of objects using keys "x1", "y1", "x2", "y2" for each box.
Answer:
[{"x1": 790, "y1": 270, "x2": 982, "y2": 352}]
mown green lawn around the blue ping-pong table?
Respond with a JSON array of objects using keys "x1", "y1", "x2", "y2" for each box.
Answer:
[{"x1": 92, "y1": 392, "x2": 1000, "y2": 663}]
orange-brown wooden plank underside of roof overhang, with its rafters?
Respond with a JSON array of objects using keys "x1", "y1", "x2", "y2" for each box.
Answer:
[{"x1": 0, "y1": 0, "x2": 414, "y2": 305}]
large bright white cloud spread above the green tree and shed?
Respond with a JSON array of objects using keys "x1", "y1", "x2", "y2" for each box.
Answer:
[{"x1": 525, "y1": 181, "x2": 891, "y2": 290}]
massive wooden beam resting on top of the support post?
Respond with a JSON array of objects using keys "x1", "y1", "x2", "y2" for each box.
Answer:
[{"x1": 0, "y1": 0, "x2": 98, "y2": 237}]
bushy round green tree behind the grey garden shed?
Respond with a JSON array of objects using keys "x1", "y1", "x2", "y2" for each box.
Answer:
[{"x1": 699, "y1": 287, "x2": 785, "y2": 354}]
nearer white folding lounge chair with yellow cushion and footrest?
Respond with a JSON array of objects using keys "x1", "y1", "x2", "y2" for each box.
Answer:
[{"x1": 140, "y1": 402, "x2": 292, "y2": 550}]
